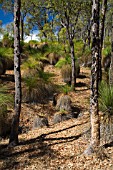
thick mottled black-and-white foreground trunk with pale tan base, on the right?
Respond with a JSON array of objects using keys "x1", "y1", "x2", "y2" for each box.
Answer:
[{"x1": 85, "y1": 0, "x2": 100, "y2": 154}]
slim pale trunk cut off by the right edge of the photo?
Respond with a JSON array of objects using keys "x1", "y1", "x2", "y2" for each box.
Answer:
[{"x1": 109, "y1": 13, "x2": 113, "y2": 86}]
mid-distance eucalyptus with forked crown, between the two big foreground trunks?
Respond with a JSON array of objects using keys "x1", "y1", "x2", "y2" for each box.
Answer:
[{"x1": 49, "y1": 0, "x2": 81, "y2": 90}]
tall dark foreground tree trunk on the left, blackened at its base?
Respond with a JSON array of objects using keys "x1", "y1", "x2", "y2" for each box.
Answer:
[{"x1": 9, "y1": 0, "x2": 21, "y2": 146}]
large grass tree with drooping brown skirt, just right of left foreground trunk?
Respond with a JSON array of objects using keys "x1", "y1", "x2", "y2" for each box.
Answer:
[{"x1": 22, "y1": 76, "x2": 56, "y2": 103}]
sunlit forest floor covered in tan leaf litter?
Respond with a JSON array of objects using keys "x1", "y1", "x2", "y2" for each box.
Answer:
[{"x1": 0, "y1": 66, "x2": 113, "y2": 170}]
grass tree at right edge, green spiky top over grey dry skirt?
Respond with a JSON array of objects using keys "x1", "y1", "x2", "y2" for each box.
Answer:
[{"x1": 99, "y1": 81, "x2": 113, "y2": 143}]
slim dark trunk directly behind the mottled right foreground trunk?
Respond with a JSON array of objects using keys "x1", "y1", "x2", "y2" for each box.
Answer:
[{"x1": 99, "y1": 0, "x2": 107, "y2": 81}]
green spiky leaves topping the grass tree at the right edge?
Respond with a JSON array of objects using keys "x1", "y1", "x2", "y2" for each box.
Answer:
[{"x1": 99, "y1": 81, "x2": 113, "y2": 115}]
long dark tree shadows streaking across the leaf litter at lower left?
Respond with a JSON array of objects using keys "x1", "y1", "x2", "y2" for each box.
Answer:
[{"x1": 0, "y1": 119, "x2": 88, "y2": 170}]
